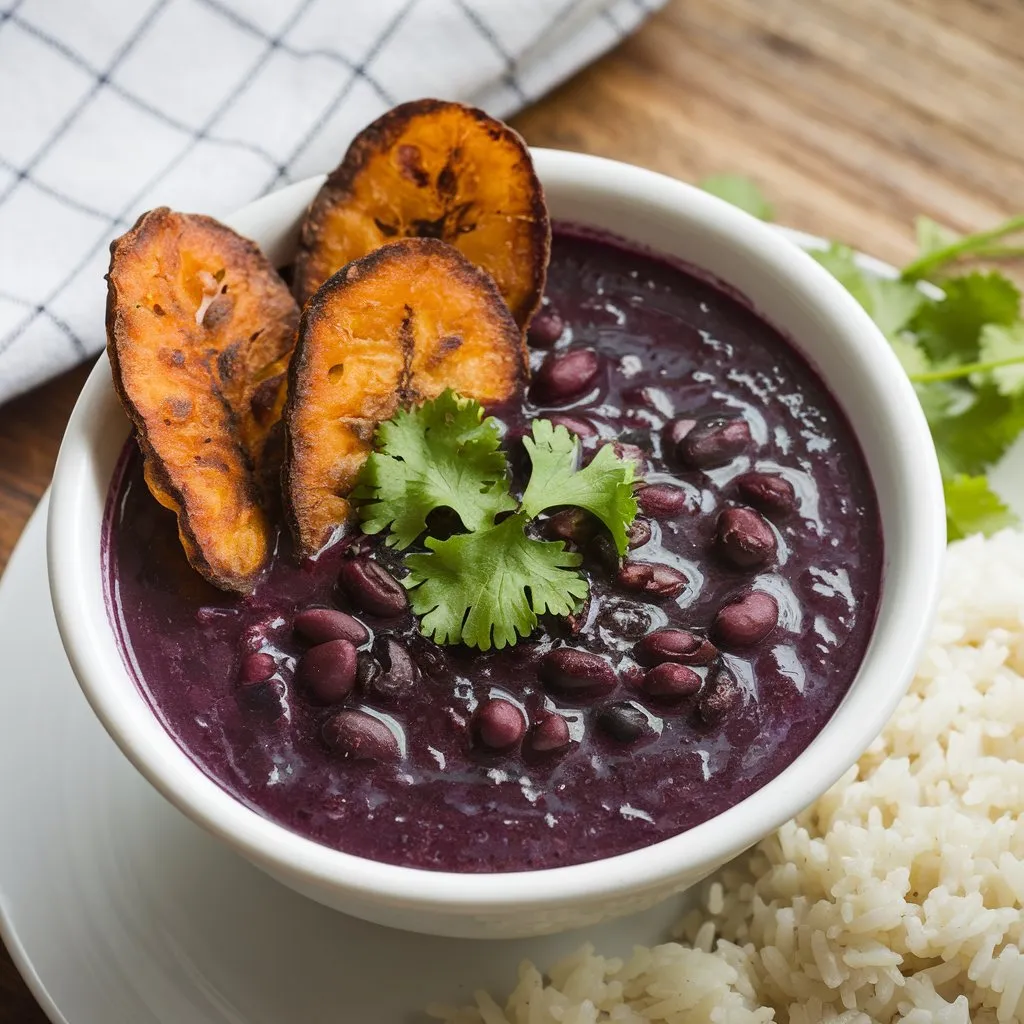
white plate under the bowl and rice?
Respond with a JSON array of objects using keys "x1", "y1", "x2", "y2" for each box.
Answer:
[{"x1": 0, "y1": 232, "x2": 1024, "y2": 1024}]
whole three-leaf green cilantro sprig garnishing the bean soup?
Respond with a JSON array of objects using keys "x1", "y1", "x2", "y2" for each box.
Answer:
[{"x1": 355, "y1": 390, "x2": 637, "y2": 650}]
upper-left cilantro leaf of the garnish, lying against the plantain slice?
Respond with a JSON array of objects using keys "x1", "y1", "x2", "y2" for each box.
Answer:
[{"x1": 355, "y1": 390, "x2": 516, "y2": 549}]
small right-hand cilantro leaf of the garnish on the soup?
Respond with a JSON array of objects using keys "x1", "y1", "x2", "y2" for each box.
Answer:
[{"x1": 522, "y1": 420, "x2": 637, "y2": 555}]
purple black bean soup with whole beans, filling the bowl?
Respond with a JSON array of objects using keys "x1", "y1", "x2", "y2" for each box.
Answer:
[{"x1": 103, "y1": 226, "x2": 883, "y2": 872}]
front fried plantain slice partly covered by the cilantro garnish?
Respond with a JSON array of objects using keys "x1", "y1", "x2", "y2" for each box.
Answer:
[{"x1": 284, "y1": 239, "x2": 526, "y2": 555}]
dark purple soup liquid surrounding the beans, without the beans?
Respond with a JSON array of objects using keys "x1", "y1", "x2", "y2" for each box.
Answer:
[{"x1": 104, "y1": 231, "x2": 882, "y2": 871}]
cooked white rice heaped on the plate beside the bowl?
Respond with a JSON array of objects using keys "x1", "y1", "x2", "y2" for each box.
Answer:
[{"x1": 430, "y1": 530, "x2": 1024, "y2": 1024}]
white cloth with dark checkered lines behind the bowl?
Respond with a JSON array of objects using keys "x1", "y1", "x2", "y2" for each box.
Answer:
[{"x1": 0, "y1": 0, "x2": 664, "y2": 402}]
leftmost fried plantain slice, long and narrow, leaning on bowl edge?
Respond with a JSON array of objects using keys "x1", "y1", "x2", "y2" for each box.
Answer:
[{"x1": 106, "y1": 207, "x2": 298, "y2": 592}]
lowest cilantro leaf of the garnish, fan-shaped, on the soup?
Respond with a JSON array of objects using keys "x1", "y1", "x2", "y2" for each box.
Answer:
[{"x1": 402, "y1": 512, "x2": 587, "y2": 650}]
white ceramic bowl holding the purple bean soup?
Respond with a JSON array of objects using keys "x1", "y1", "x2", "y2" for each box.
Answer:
[{"x1": 48, "y1": 150, "x2": 945, "y2": 937}]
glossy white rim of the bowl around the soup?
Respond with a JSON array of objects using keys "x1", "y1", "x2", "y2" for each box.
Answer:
[{"x1": 47, "y1": 150, "x2": 945, "y2": 913}]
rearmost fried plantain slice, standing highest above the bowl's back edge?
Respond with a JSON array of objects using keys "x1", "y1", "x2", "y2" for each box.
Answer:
[{"x1": 294, "y1": 99, "x2": 551, "y2": 329}]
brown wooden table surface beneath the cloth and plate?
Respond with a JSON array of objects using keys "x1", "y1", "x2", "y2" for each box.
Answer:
[{"x1": 0, "y1": 0, "x2": 1024, "y2": 1024}]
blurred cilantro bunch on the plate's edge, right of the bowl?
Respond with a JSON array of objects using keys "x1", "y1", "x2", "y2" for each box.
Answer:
[{"x1": 701, "y1": 175, "x2": 1024, "y2": 540}]
